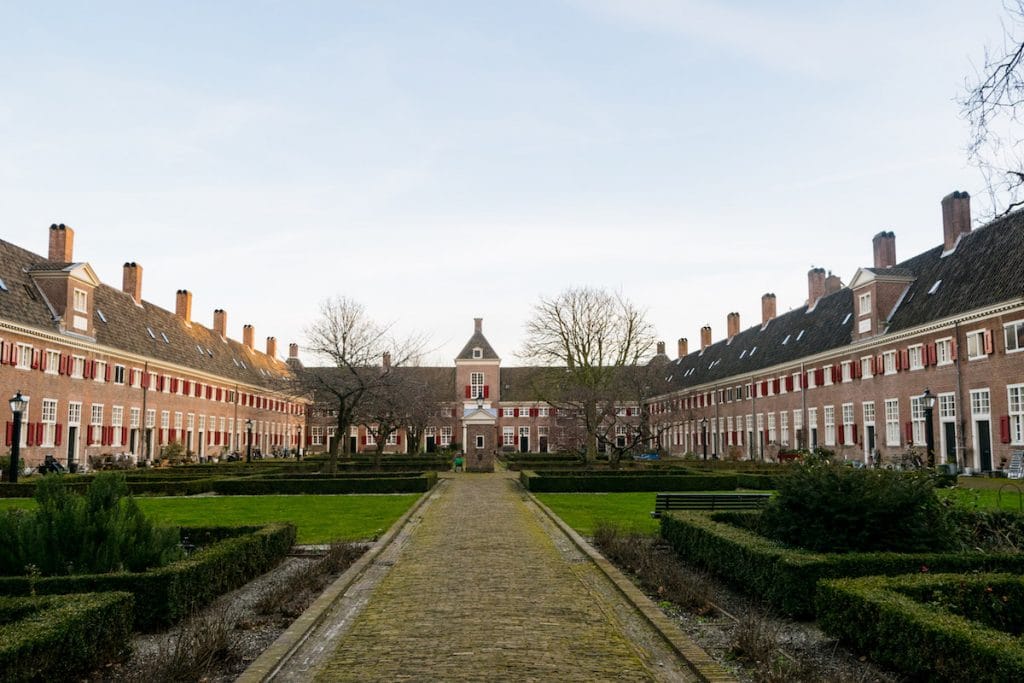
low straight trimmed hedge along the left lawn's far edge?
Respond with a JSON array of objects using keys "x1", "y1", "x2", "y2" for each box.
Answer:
[{"x1": 213, "y1": 472, "x2": 437, "y2": 496}]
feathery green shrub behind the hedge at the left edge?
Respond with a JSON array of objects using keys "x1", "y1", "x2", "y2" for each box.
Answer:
[{"x1": 0, "y1": 473, "x2": 181, "y2": 575}]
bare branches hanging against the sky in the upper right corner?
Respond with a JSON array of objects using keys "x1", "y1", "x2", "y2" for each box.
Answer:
[{"x1": 959, "y1": 0, "x2": 1024, "y2": 217}]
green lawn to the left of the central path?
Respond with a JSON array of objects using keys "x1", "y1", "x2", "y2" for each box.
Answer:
[{"x1": 0, "y1": 494, "x2": 420, "y2": 544}]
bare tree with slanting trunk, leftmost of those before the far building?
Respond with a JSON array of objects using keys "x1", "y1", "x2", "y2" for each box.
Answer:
[{"x1": 299, "y1": 296, "x2": 425, "y2": 472}]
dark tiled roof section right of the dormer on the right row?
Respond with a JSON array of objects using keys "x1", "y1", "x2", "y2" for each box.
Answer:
[{"x1": 888, "y1": 212, "x2": 1024, "y2": 333}]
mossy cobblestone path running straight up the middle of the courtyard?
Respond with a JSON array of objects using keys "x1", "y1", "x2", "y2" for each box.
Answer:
[{"x1": 309, "y1": 473, "x2": 688, "y2": 681}]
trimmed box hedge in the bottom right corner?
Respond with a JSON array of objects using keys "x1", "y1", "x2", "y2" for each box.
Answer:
[{"x1": 816, "y1": 573, "x2": 1024, "y2": 681}]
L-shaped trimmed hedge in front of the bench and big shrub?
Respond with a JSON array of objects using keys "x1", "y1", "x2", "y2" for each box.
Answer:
[{"x1": 662, "y1": 512, "x2": 1024, "y2": 617}]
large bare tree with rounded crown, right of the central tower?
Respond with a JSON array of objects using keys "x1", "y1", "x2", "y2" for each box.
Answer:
[{"x1": 520, "y1": 288, "x2": 654, "y2": 462}]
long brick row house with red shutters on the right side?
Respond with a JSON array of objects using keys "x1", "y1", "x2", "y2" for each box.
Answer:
[{"x1": 647, "y1": 191, "x2": 1024, "y2": 470}]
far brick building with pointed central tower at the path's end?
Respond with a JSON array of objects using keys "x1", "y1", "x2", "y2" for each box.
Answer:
[{"x1": 308, "y1": 317, "x2": 638, "y2": 455}]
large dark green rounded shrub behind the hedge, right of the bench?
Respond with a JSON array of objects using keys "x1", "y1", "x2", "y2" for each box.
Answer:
[{"x1": 761, "y1": 462, "x2": 953, "y2": 553}]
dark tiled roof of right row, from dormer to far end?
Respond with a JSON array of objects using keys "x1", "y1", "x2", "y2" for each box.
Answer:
[{"x1": 665, "y1": 288, "x2": 853, "y2": 390}]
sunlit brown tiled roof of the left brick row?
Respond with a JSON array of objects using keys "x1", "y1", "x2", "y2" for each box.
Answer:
[{"x1": 0, "y1": 235, "x2": 291, "y2": 386}]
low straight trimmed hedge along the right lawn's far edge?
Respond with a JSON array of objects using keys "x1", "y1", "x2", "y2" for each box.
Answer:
[{"x1": 519, "y1": 470, "x2": 736, "y2": 494}]
